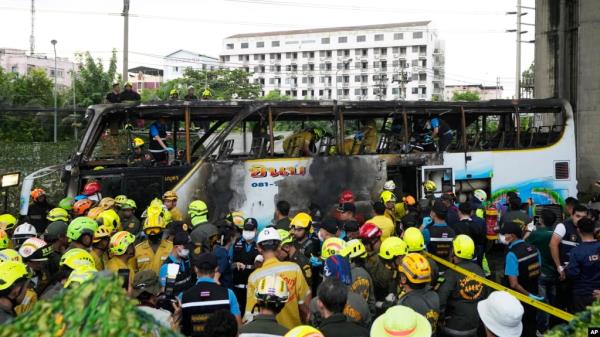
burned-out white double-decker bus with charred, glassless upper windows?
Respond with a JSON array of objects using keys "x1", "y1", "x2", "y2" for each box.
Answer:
[{"x1": 22, "y1": 99, "x2": 577, "y2": 226}]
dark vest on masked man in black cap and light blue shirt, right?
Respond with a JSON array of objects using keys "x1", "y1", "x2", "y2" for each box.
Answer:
[{"x1": 508, "y1": 241, "x2": 542, "y2": 295}]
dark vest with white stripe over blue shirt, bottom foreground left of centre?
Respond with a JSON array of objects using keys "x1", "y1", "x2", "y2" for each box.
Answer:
[{"x1": 181, "y1": 281, "x2": 230, "y2": 337}]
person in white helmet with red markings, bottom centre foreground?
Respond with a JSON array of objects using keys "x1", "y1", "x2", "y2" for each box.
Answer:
[{"x1": 239, "y1": 275, "x2": 289, "y2": 337}]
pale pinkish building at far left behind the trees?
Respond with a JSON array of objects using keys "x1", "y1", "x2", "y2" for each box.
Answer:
[{"x1": 0, "y1": 48, "x2": 77, "y2": 88}]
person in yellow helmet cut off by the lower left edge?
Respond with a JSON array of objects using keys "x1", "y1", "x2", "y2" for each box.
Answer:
[{"x1": 0, "y1": 261, "x2": 29, "y2": 324}]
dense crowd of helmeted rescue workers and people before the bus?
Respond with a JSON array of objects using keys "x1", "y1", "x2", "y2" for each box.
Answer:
[{"x1": 0, "y1": 181, "x2": 600, "y2": 337}]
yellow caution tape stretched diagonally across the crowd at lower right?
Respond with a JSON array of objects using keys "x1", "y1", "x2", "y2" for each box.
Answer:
[{"x1": 423, "y1": 252, "x2": 575, "y2": 322}]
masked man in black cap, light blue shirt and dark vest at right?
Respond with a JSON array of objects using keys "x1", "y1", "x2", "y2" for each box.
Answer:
[{"x1": 499, "y1": 222, "x2": 544, "y2": 336}]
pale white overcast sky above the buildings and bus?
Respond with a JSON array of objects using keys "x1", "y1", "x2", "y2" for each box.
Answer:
[{"x1": 0, "y1": 0, "x2": 535, "y2": 97}]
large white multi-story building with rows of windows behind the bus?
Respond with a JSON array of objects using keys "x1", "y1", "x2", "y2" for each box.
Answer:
[{"x1": 220, "y1": 21, "x2": 444, "y2": 100}]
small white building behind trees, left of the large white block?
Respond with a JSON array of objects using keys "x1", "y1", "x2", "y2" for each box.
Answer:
[{"x1": 163, "y1": 49, "x2": 219, "y2": 81}]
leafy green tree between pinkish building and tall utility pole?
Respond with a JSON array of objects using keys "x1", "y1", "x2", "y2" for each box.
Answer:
[{"x1": 73, "y1": 49, "x2": 120, "y2": 106}]
